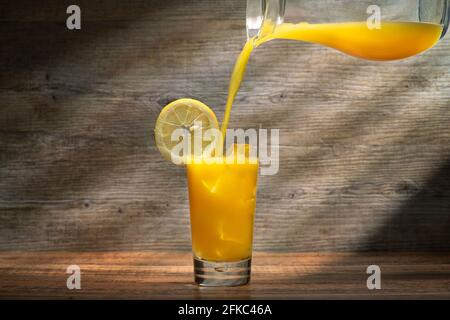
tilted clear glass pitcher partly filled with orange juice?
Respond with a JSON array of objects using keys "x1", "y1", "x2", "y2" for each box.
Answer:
[{"x1": 246, "y1": 0, "x2": 450, "y2": 60}]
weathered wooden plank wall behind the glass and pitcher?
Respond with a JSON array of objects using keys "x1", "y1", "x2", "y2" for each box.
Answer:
[{"x1": 0, "y1": 0, "x2": 450, "y2": 252}]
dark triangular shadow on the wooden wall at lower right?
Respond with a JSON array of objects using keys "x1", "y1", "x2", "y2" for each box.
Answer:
[{"x1": 361, "y1": 160, "x2": 450, "y2": 252}]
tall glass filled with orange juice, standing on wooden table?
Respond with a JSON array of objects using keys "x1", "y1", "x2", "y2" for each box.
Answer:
[{"x1": 187, "y1": 154, "x2": 258, "y2": 286}]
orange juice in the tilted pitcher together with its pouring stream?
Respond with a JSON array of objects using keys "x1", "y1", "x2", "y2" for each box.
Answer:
[{"x1": 222, "y1": 22, "x2": 442, "y2": 136}]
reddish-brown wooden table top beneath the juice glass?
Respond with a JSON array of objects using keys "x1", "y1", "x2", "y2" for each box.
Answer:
[{"x1": 0, "y1": 252, "x2": 450, "y2": 299}]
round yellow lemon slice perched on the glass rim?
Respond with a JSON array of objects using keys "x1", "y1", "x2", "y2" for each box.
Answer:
[{"x1": 155, "y1": 99, "x2": 219, "y2": 164}]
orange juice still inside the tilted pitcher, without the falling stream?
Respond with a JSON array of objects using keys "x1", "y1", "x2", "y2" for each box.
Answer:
[{"x1": 270, "y1": 22, "x2": 442, "y2": 61}]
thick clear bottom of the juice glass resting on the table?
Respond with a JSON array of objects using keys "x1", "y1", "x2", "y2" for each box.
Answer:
[{"x1": 194, "y1": 257, "x2": 252, "y2": 287}]
